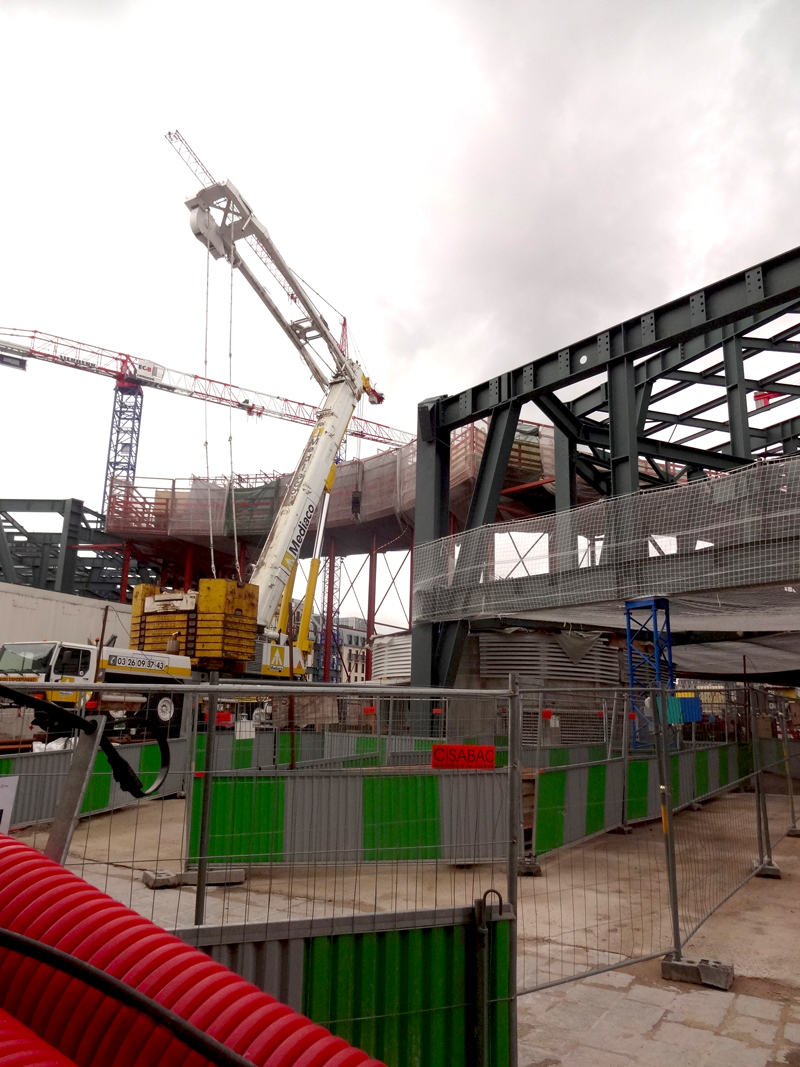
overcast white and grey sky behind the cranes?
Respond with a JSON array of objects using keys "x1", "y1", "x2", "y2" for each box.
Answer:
[{"x1": 0, "y1": 0, "x2": 800, "y2": 516}]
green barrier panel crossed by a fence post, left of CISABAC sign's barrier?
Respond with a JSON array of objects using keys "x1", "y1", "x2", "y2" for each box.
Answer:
[{"x1": 190, "y1": 775, "x2": 286, "y2": 863}]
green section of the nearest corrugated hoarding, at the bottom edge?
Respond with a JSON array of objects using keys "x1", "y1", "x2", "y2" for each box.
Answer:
[{"x1": 303, "y1": 922, "x2": 486, "y2": 1067}]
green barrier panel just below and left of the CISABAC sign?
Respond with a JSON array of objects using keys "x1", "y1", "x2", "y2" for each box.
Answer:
[{"x1": 363, "y1": 775, "x2": 442, "y2": 860}]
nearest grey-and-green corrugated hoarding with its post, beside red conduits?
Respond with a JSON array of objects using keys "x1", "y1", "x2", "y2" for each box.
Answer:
[{"x1": 180, "y1": 907, "x2": 512, "y2": 1067}]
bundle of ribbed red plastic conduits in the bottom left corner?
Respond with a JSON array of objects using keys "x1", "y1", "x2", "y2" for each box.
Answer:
[{"x1": 0, "y1": 834, "x2": 384, "y2": 1067}]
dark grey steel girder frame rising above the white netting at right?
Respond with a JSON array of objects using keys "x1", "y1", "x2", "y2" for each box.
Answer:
[{"x1": 412, "y1": 249, "x2": 800, "y2": 686}]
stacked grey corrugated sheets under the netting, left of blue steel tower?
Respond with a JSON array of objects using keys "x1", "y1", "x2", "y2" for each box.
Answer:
[{"x1": 478, "y1": 633, "x2": 620, "y2": 686}]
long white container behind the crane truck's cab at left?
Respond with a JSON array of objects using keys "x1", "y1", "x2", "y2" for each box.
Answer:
[{"x1": 0, "y1": 582, "x2": 131, "y2": 649}]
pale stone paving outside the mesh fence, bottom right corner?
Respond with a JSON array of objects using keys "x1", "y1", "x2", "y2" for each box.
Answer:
[{"x1": 517, "y1": 840, "x2": 800, "y2": 1067}]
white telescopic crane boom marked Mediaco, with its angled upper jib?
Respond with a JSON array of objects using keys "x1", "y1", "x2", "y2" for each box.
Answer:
[{"x1": 173, "y1": 131, "x2": 384, "y2": 676}]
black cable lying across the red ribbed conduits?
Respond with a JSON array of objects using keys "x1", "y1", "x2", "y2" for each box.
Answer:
[{"x1": 0, "y1": 927, "x2": 253, "y2": 1067}]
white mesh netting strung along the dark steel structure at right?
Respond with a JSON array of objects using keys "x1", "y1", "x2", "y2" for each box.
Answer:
[{"x1": 414, "y1": 456, "x2": 800, "y2": 622}]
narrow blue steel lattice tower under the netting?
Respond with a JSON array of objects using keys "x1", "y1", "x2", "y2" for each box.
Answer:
[{"x1": 625, "y1": 596, "x2": 675, "y2": 748}]
